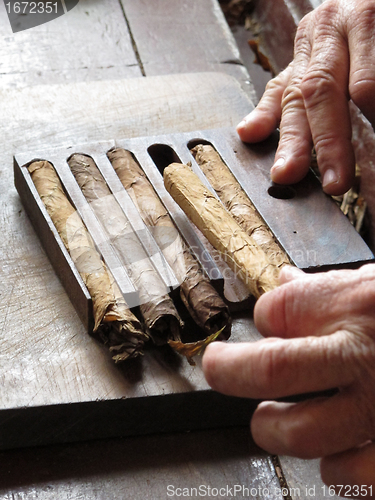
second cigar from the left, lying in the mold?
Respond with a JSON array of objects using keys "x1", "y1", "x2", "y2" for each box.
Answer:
[{"x1": 68, "y1": 154, "x2": 182, "y2": 345}]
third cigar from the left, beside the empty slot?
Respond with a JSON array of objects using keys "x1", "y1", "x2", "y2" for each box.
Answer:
[{"x1": 107, "y1": 148, "x2": 231, "y2": 338}]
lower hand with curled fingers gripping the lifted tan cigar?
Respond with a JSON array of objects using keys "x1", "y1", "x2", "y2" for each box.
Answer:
[{"x1": 203, "y1": 264, "x2": 375, "y2": 493}]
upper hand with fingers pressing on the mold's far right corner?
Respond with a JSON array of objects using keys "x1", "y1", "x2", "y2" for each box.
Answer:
[{"x1": 237, "y1": 0, "x2": 375, "y2": 195}]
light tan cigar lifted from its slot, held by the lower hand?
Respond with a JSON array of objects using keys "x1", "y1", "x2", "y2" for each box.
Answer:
[{"x1": 164, "y1": 163, "x2": 280, "y2": 298}]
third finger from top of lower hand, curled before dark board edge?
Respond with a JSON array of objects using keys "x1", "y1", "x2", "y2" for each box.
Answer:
[{"x1": 251, "y1": 393, "x2": 368, "y2": 458}]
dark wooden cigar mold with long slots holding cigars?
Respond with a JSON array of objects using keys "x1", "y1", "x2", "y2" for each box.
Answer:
[{"x1": 14, "y1": 129, "x2": 373, "y2": 331}]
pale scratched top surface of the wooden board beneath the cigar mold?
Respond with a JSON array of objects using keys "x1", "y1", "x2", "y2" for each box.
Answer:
[{"x1": 0, "y1": 73, "x2": 257, "y2": 450}]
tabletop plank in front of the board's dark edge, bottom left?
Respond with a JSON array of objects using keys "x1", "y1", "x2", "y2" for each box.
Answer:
[{"x1": 0, "y1": 427, "x2": 283, "y2": 500}]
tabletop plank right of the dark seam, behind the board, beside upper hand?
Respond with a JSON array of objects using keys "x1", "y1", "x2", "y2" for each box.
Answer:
[{"x1": 121, "y1": 0, "x2": 253, "y2": 99}]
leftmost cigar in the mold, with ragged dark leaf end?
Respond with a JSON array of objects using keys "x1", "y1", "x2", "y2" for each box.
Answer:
[{"x1": 28, "y1": 161, "x2": 148, "y2": 362}]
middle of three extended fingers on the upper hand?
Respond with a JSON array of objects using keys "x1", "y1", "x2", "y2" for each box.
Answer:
[{"x1": 271, "y1": 21, "x2": 312, "y2": 184}]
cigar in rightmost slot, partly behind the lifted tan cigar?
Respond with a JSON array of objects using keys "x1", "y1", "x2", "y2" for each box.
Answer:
[{"x1": 191, "y1": 144, "x2": 290, "y2": 267}]
